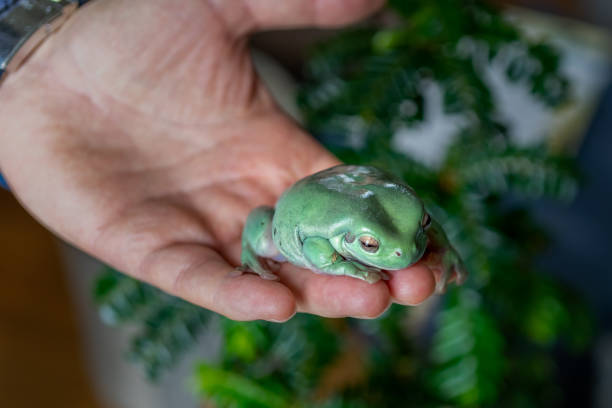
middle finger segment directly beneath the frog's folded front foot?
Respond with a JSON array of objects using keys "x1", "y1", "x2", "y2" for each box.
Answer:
[{"x1": 279, "y1": 264, "x2": 390, "y2": 318}]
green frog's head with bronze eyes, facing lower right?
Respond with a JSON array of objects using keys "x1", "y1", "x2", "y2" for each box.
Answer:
[{"x1": 342, "y1": 209, "x2": 431, "y2": 270}]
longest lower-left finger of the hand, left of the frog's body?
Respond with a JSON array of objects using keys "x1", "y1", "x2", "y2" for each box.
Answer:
[{"x1": 140, "y1": 244, "x2": 295, "y2": 322}]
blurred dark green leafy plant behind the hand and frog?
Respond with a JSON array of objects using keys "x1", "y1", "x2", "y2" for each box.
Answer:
[{"x1": 97, "y1": 0, "x2": 592, "y2": 408}]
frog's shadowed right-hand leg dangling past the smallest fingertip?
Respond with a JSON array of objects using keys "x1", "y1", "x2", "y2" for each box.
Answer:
[{"x1": 427, "y1": 220, "x2": 467, "y2": 293}]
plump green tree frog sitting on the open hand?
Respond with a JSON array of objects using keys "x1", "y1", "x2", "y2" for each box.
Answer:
[{"x1": 239, "y1": 165, "x2": 467, "y2": 292}]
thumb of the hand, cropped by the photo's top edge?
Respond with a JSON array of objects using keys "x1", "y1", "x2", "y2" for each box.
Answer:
[{"x1": 216, "y1": 0, "x2": 384, "y2": 34}]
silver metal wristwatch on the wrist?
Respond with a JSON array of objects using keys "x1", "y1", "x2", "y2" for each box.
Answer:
[{"x1": 0, "y1": 0, "x2": 84, "y2": 81}]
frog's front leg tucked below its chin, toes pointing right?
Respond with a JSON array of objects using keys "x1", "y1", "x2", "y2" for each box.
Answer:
[{"x1": 302, "y1": 237, "x2": 386, "y2": 283}]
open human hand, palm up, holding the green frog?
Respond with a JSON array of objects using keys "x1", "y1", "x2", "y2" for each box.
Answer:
[{"x1": 0, "y1": 0, "x2": 435, "y2": 321}]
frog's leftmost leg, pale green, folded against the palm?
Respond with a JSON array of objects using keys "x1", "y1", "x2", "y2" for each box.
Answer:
[{"x1": 238, "y1": 206, "x2": 280, "y2": 280}]
